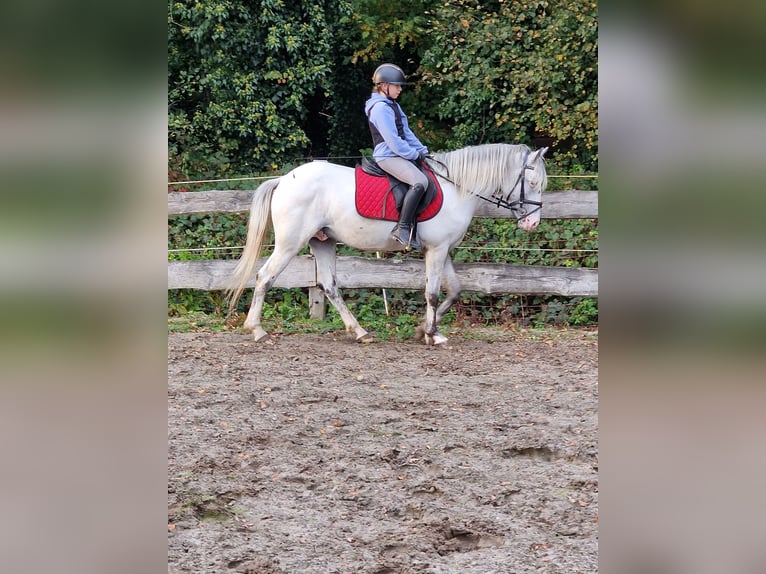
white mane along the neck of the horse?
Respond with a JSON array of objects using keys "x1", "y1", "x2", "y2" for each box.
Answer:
[{"x1": 431, "y1": 144, "x2": 545, "y2": 200}]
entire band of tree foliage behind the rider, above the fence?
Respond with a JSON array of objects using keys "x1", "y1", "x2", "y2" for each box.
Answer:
[{"x1": 168, "y1": 0, "x2": 598, "y2": 177}]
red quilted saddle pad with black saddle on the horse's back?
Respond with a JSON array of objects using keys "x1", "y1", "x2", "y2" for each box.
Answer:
[{"x1": 354, "y1": 157, "x2": 444, "y2": 221}]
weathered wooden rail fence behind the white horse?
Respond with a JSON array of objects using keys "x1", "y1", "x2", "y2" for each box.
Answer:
[{"x1": 168, "y1": 191, "x2": 598, "y2": 317}]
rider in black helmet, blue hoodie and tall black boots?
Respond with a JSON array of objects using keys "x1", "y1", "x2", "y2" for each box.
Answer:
[{"x1": 364, "y1": 64, "x2": 428, "y2": 250}]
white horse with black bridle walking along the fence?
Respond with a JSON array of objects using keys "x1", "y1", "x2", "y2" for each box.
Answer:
[{"x1": 227, "y1": 143, "x2": 548, "y2": 346}]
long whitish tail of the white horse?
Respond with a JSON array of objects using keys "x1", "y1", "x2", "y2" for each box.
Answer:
[{"x1": 226, "y1": 178, "x2": 280, "y2": 312}]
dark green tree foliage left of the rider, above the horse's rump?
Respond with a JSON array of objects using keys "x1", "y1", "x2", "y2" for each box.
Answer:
[{"x1": 168, "y1": 0, "x2": 350, "y2": 175}]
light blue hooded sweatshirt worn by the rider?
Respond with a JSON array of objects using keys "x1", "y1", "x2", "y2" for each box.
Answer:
[{"x1": 364, "y1": 92, "x2": 428, "y2": 161}]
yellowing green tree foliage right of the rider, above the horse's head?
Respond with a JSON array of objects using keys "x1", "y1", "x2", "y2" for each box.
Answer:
[{"x1": 421, "y1": 0, "x2": 598, "y2": 170}]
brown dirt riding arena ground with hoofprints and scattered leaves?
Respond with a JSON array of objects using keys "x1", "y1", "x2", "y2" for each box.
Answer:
[{"x1": 168, "y1": 330, "x2": 598, "y2": 574}]
